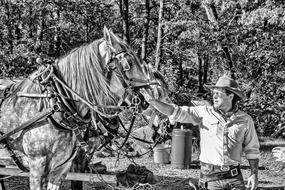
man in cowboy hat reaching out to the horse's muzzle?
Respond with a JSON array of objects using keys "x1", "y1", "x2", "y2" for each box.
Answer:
[{"x1": 150, "y1": 76, "x2": 260, "y2": 190}]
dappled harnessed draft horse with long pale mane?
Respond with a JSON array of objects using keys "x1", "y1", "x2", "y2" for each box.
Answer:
[{"x1": 0, "y1": 27, "x2": 160, "y2": 190}]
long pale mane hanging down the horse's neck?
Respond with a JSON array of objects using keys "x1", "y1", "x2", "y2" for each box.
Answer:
[{"x1": 58, "y1": 39, "x2": 119, "y2": 109}]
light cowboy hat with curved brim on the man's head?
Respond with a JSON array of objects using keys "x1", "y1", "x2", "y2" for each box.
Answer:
[{"x1": 205, "y1": 75, "x2": 245, "y2": 100}]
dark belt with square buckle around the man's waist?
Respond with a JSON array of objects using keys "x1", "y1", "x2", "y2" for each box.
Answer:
[{"x1": 200, "y1": 163, "x2": 241, "y2": 181}]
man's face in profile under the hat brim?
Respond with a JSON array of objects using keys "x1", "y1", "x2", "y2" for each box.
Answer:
[{"x1": 212, "y1": 88, "x2": 233, "y2": 112}]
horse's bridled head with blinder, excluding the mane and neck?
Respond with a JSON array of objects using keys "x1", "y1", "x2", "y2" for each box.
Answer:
[{"x1": 99, "y1": 28, "x2": 156, "y2": 113}]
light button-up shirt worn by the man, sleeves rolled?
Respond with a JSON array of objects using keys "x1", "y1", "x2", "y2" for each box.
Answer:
[{"x1": 170, "y1": 106, "x2": 260, "y2": 166}]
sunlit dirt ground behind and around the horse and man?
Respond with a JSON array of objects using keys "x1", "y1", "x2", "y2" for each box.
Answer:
[{"x1": 4, "y1": 151, "x2": 285, "y2": 190}]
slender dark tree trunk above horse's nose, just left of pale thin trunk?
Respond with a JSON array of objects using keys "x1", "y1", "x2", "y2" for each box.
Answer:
[{"x1": 141, "y1": 0, "x2": 150, "y2": 62}]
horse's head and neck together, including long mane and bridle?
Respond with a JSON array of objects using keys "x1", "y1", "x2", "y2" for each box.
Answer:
[{"x1": 56, "y1": 28, "x2": 169, "y2": 115}]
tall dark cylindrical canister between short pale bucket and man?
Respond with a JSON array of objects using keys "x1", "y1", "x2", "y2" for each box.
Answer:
[{"x1": 171, "y1": 129, "x2": 192, "y2": 169}]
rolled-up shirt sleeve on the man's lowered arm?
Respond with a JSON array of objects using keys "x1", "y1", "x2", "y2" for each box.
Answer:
[{"x1": 244, "y1": 116, "x2": 260, "y2": 159}]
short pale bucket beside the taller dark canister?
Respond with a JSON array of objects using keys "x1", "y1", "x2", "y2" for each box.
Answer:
[{"x1": 153, "y1": 144, "x2": 170, "y2": 164}]
